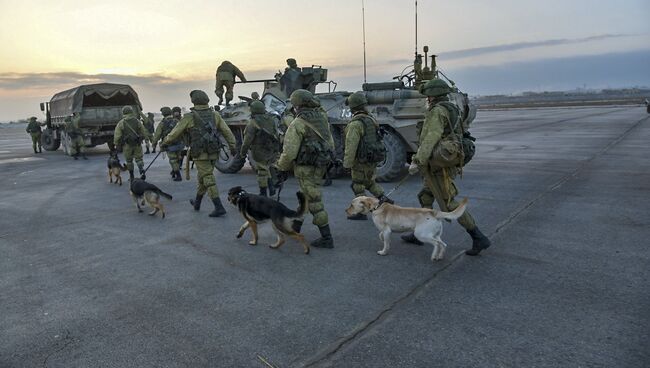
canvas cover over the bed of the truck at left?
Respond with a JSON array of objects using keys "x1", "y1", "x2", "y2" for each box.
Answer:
[{"x1": 50, "y1": 83, "x2": 142, "y2": 116}]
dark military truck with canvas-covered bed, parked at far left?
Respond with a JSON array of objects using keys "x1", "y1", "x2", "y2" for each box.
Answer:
[{"x1": 41, "y1": 83, "x2": 142, "y2": 154}]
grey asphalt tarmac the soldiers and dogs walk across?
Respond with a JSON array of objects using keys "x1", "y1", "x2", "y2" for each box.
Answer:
[{"x1": 0, "y1": 106, "x2": 650, "y2": 368}]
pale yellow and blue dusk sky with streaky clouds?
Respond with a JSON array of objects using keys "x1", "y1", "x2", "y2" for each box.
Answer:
[{"x1": 0, "y1": 0, "x2": 650, "y2": 120}]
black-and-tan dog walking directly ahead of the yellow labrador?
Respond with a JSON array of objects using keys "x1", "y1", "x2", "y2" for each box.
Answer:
[{"x1": 228, "y1": 187, "x2": 309, "y2": 254}]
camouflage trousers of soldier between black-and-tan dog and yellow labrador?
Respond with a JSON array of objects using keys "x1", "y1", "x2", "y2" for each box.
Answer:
[{"x1": 293, "y1": 165, "x2": 329, "y2": 227}]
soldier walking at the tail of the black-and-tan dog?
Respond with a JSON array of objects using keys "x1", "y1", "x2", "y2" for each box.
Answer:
[{"x1": 277, "y1": 89, "x2": 334, "y2": 248}]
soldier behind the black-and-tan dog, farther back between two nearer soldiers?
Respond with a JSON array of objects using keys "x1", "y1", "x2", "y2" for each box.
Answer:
[{"x1": 239, "y1": 101, "x2": 280, "y2": 197}]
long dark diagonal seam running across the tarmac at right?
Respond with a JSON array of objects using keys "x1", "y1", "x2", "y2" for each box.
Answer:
[{"x1": 291, "y1": 110, "x2": 650, "y2": 367}]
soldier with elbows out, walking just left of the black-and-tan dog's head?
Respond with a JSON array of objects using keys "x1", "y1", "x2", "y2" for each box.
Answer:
[{"x1": 163, "y1": 90, "x2": 237, "y2": 217}]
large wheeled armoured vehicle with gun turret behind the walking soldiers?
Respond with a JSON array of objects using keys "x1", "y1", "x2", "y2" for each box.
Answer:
[{"x1": 216, "y1": 46, "x2": 476, "y2": 181}]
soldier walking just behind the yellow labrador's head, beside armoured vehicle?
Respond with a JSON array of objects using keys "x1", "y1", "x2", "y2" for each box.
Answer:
[{"x1": 343, "y1": 92, "x2": 393, "y2": 220}]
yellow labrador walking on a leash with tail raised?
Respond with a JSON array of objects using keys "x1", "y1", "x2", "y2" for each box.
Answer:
[{"x1": 345, "y1": 196, "x2": 467, "y2": 261}]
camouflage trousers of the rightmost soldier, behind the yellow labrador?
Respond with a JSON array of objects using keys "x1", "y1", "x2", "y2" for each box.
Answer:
[{"x1": 418, "y1": 165, "x2": 476, "y2": 230}]
